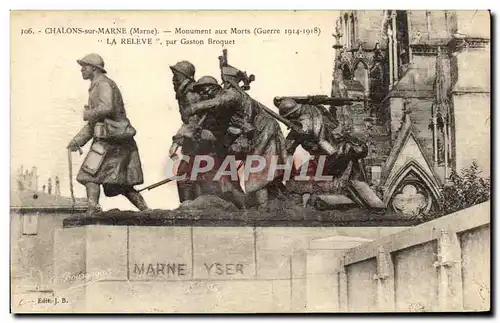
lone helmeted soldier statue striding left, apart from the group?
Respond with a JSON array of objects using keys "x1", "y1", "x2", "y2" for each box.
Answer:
[{"x1": 68, "y1": 54, "x2": 148, "y2": 215}]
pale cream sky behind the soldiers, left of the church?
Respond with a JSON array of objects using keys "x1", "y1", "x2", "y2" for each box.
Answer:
[{"x1": 11, "y1": 11, "x2": 338, "y2": 210}]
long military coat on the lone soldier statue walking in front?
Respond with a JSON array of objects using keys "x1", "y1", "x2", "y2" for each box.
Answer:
[{"x1": 73, "y1": 74, "x2": 143, "y2": 196}]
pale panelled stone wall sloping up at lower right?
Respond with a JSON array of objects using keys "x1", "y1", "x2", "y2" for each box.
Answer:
[{"x1": 309, "y1": 202, "x2": 491, "y2": 312}]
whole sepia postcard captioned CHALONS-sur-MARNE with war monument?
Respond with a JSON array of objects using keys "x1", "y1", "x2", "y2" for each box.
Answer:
[{"x1": 10, "y1": 10, "x2": 491, "y2": 313}]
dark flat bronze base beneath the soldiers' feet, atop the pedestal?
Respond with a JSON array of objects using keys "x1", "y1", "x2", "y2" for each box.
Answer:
[{"x1": 63, "y1": 208, "x2": 421, "y2": 227}]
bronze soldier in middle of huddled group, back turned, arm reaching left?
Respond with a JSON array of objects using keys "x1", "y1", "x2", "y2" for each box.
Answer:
[{"x1": 186, "y1": 56, "x2": 286, "y2": 206}]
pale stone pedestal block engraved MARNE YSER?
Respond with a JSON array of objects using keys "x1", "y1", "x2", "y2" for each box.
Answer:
[{"x1": 45, "y1": 225, "x2": 408, "y2": 313}]
